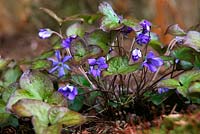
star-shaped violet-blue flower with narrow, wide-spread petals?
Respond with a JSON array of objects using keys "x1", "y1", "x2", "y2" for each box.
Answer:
[{"x1": 48, "y1": 50, "x2": 72, "y2": 77}]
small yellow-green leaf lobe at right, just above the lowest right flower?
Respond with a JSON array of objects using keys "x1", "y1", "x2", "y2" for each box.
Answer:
[{"x1": 158, "y1": 79, "x2": 180, "y2": 89}]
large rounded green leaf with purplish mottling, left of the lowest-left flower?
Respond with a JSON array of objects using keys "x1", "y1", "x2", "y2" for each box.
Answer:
[{"x1": 19, "y1": 70, "x2": 54, "y2": 99}]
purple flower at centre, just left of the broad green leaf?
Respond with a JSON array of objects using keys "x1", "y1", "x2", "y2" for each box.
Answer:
[{"x1": 88, "y1": 57, "x2": 108, "y2": 77}]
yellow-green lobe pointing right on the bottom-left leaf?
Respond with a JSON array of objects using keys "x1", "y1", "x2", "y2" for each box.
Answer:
[{"x1": 49, "y1": 107, "x2": 86, "y2": 126}]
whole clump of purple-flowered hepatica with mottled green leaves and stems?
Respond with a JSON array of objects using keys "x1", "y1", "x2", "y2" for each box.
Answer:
[{"x1": 0, "y1": 2, "x2": 200, "y2": 134}]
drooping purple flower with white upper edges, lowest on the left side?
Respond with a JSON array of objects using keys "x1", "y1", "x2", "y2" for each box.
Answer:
[{"x1": 58, "y1": 85, "x2": 78, "y2": 100}]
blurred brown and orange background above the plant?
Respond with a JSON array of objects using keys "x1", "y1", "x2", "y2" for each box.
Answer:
[{"x1": 0, "y1": 0, "x2": 200, "y2": 60}]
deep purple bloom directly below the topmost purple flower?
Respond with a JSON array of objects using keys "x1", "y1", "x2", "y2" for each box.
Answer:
[{"x1": 135, "y1": 33, "x2": 151, "y2": 45}]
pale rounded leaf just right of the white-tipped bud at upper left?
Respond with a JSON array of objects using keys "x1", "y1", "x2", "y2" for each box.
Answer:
[{"x1": 66, "y1": 23, "x2": 85, "y2": 37}]
